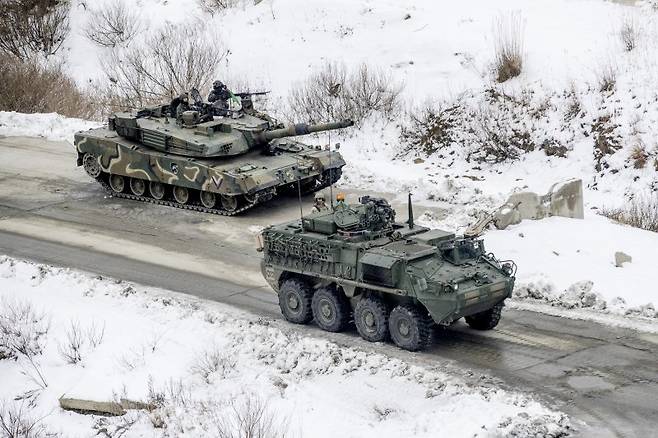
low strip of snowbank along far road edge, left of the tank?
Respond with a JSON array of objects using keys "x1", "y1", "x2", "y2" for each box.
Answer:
[{"x1": 0, "y1": 111, "x2": 101, "y2": 143}]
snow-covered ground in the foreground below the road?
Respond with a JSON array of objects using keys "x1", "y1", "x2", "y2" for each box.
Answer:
[{"x1": 0, "y1": 257, "x2": 569, "y2": 437}]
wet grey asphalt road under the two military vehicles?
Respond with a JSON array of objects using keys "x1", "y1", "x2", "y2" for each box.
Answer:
[{"x1": 0, "y1": 138, "x2": 658, "y2": 437}]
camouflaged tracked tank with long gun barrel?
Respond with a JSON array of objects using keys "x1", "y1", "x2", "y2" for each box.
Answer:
[{"x1": 75, "y1": 100, "x2": 353, "y2": 215}]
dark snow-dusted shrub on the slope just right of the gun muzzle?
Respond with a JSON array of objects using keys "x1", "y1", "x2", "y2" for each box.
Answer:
[{"x1": 400, "y1": 102, "x2": 463, "y2": 156}]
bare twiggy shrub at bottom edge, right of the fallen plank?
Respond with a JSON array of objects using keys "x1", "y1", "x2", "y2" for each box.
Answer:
[{"x1": 214, "y1": 396, "x2": 287, "y2": 438}]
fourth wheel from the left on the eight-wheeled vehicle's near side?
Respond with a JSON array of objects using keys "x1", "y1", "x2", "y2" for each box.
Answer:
[{"x1": 388, "y1": 304, "x2": 431, "y2": 351}]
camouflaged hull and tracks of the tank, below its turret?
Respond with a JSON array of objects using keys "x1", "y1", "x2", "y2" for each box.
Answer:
[{"x1": 75, "y1": 128, "x2": 345, "y2": 214}]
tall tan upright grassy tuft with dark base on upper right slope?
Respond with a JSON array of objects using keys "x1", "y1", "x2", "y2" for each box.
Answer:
[{"x1": 494, "y1": 14, "x2": 525, "y2": 82}]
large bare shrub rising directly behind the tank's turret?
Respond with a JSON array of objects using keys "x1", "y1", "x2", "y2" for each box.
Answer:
[{"x1": 102, "y1": 23, "x2": 226, "y2": 108}]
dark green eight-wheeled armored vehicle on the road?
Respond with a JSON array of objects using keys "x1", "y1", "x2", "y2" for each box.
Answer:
[{"x1": 259, "y1": 196, "x2": 516, "y2": 351}]
